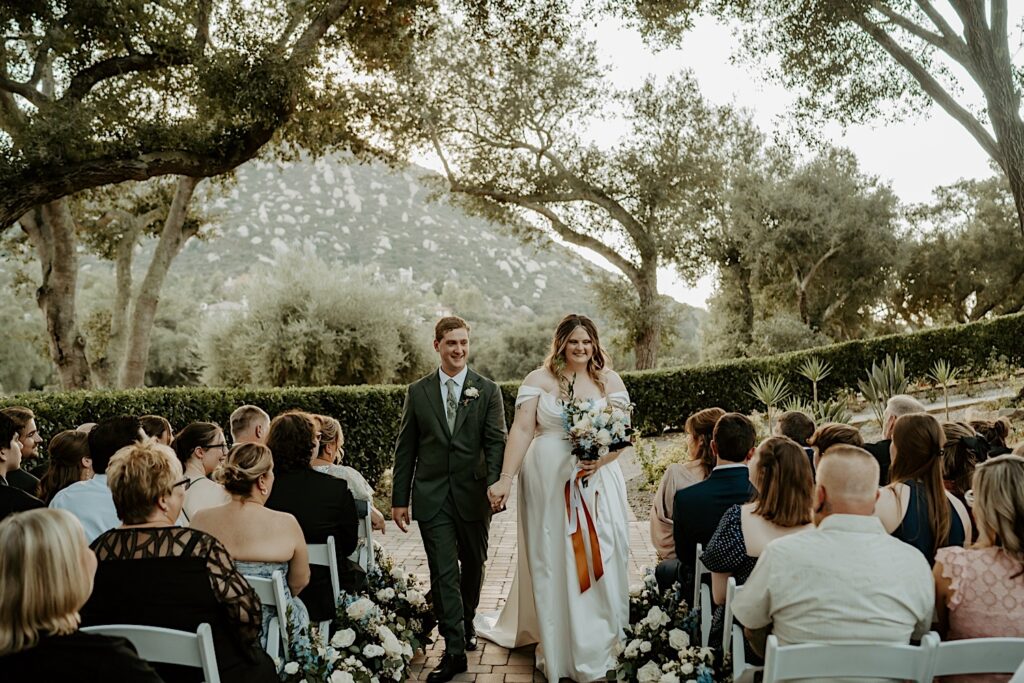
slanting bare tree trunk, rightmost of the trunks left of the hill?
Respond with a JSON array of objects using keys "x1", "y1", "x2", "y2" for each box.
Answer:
[{"x1": 120, "y1": 176, "x2": 201, "y2": 387}]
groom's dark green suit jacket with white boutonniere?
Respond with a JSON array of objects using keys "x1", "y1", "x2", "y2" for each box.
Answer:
[{"x1": 391, "y1": 369, "x2": 508, "y2": 521}]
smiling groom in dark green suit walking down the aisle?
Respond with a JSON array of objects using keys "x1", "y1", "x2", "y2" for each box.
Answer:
[{"x1": 391, "y1": 315, "x2": 506, "y2": 683}]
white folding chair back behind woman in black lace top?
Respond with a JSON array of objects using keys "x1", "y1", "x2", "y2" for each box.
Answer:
[{"x1": 82, "y1": 624, "x2": 220, "y2": 683}]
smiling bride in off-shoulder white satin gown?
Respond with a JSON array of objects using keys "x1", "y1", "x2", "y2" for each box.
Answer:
[{"x1": 475, "y1": 314, "x2": 630, "y2": 683}]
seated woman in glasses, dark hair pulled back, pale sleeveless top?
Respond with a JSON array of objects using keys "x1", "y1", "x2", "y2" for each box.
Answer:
[{"x1": 171, "y1": 422, "x2": 231, "y2": 520}]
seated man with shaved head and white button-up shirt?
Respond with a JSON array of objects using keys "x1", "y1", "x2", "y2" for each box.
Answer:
[{"x1": 732, "y1": 445, "x2": 934, "y2": 651}]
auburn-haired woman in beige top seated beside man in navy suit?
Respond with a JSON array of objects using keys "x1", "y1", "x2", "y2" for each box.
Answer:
[{"x1": 650, "y1": 408, "x2": 725, "y2": 560}]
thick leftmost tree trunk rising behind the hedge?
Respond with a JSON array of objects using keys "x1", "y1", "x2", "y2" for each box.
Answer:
[{"x1": 19, "y1": 200, "x2": 92, "y2": 390}]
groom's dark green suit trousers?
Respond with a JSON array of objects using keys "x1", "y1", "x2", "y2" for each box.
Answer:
[{"x1": 419, "y1": 495, "x2": 490, "y2": 654}]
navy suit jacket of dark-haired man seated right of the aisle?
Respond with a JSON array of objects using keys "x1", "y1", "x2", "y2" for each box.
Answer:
[{"x1": 672, "y1": 467, "x2": 757, "y2": 580}]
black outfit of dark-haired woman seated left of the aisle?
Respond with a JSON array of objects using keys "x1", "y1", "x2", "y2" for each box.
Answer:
[{"x1": 266, "y1": 468, "x2": 359, "y2": 622}]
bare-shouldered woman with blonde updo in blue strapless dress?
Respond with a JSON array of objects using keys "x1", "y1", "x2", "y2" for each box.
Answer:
[{"x1": 191, "y1": 443, "x2": 309, "y2": 647}]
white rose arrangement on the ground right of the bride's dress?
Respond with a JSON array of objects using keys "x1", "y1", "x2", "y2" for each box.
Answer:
[{"x1": 614, "y1": 568, "x2": 724, "y2": 683}]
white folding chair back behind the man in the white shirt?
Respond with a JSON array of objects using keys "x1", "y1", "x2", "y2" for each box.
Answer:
[{"x1": 764, "y1": 632, "x2": 939, "y2": 683}]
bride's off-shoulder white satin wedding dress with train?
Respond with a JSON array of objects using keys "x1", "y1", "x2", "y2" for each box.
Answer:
[{"x1": 474, "y1": 386, "x2": 630, "y2": 683}]
